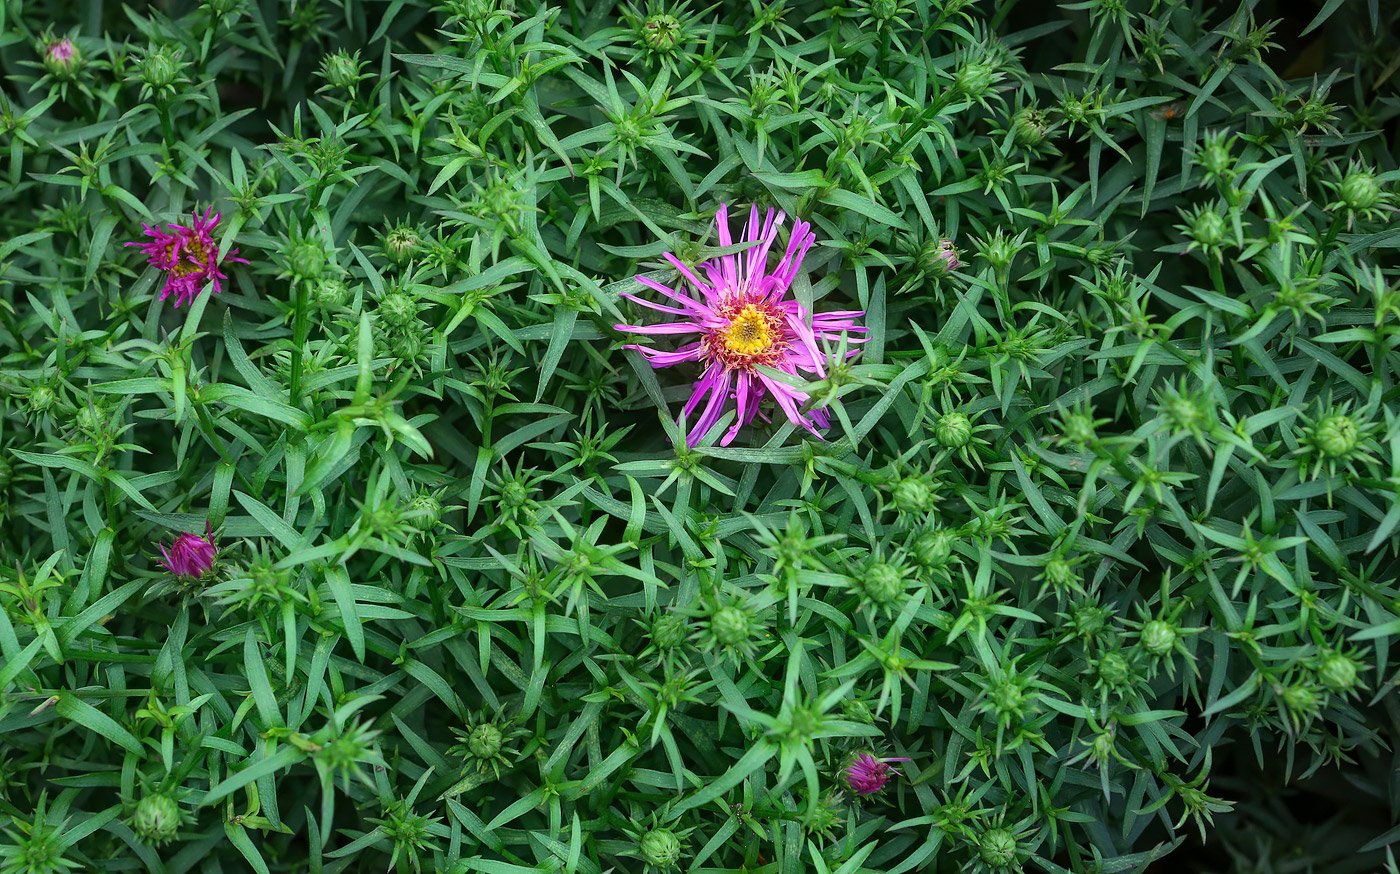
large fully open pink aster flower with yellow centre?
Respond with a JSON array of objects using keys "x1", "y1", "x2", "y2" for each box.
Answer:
[{"x1": 616, "y1": 204, "x2": 865, "y2": 445}]
